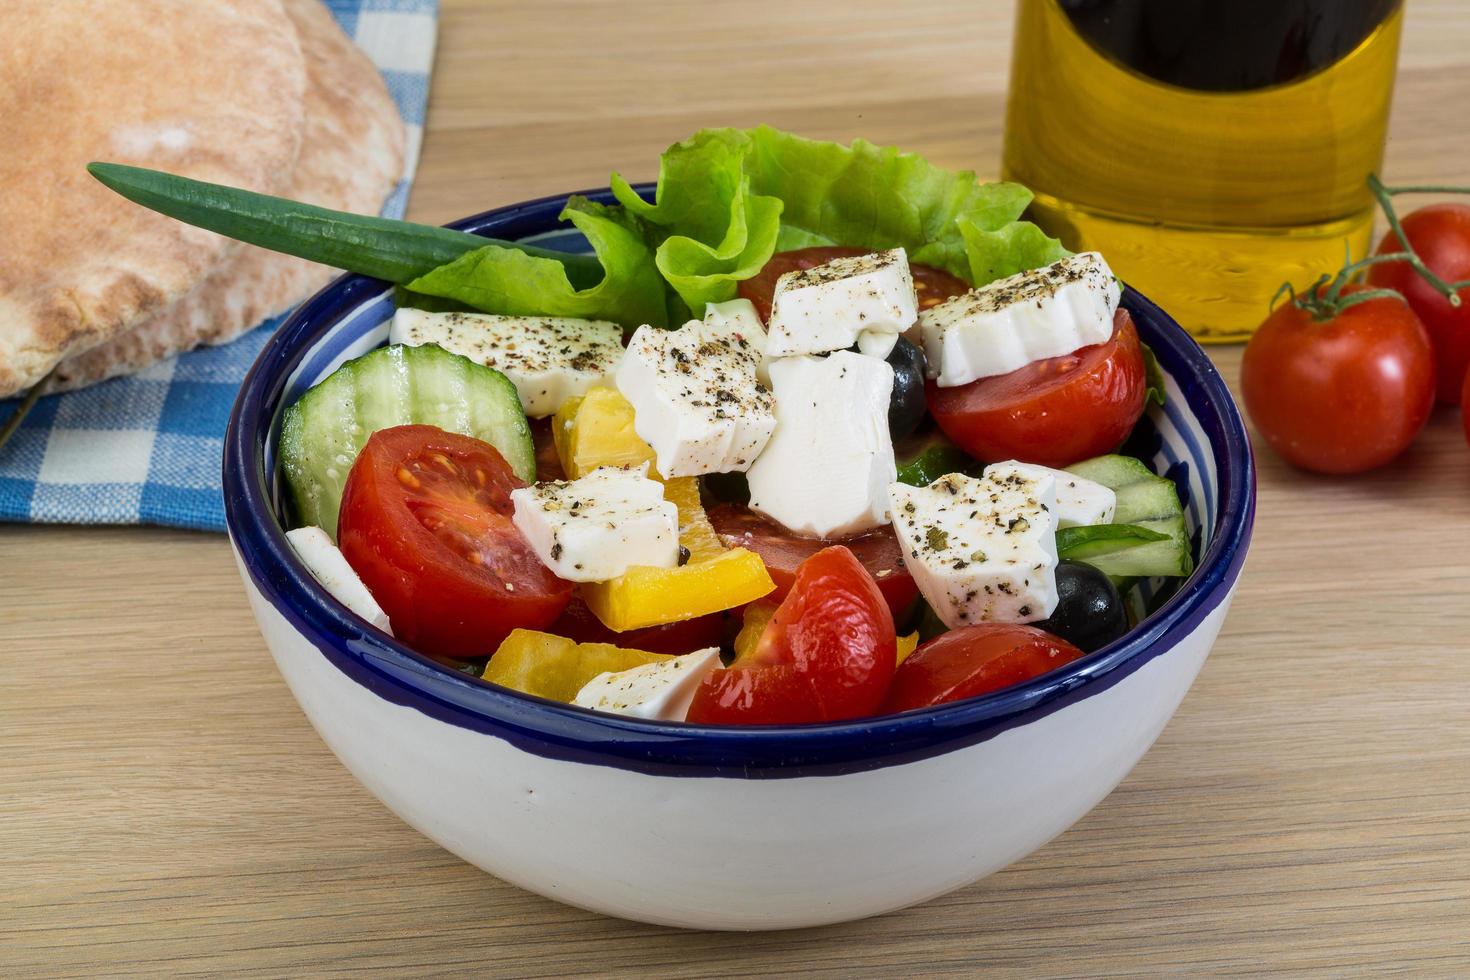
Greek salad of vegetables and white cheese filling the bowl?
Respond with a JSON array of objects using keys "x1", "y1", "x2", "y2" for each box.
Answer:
[{"x1": 264, "y1": 128, "x2": 1194, "y2": 724}]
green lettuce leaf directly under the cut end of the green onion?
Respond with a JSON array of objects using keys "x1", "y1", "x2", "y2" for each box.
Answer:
[{"x1": 406, "y1": 197, "x2": 669, "y2": 326}]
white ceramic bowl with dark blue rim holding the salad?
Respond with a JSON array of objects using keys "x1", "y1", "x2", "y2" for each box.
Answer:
[{"x1": 225, "y1": 194, "x2": 1255, "y2": 929}]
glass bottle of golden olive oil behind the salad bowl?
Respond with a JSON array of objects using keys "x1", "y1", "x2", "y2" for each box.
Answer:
[{"x1": 1003, "y1": 0, "x2": 1404, "y2": 341}]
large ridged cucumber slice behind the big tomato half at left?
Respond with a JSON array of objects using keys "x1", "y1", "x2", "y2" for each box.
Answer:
[{"x1": 281, "y1": 344, "x2": 537, "y2": 539}]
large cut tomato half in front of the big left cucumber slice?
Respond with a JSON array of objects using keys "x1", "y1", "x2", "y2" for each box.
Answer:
[{"x1": 337, "y1": 425, "x2": 572, "y2": 658}]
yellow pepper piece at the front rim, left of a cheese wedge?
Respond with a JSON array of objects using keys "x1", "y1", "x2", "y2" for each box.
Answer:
[{"x1": 481, "y1": 629, "x2": 670, "y2": 704}]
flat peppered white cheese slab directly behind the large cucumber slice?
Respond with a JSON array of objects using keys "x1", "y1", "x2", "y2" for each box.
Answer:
[{"x1": 388, "y1": 309, "x2": 623, "y2": 419}]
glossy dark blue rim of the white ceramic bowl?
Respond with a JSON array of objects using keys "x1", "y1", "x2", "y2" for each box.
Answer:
[{"x1": 223, "y1": 185, "x2": 1255, "y2": 779}]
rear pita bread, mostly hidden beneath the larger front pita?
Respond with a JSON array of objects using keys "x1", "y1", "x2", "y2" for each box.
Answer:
[{"x1": 50, "y1": 0, "x2": 404, "y2": 389}]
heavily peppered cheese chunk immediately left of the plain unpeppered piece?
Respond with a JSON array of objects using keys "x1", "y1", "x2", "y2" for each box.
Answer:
[{"x1": 616, "y1": 320, "x2": 776, "y2": 476}]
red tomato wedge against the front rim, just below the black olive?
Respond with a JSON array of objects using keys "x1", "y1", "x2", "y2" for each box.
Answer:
[{"x1": 882, "y1": 623, "x2": 1083, "y2": 714}]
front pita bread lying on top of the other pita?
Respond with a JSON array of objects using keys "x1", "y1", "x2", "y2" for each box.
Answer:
[{"x1": 0, "y1": 0, "x2": 306, "y2": 397}]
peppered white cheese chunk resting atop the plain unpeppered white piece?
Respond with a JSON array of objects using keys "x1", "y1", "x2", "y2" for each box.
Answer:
[{"x1": 766, "y1": 248, "x2": 919, "y2": 359}]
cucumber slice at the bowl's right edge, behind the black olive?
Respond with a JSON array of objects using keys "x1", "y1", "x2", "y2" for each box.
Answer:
[{"x1": 1067, "y1": 455, "x2": 1194, "y2": 588}]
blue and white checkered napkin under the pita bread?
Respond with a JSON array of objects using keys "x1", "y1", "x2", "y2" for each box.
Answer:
[{"x1": 0, "y1": 0, "x2": 438, "y2": 530}]
